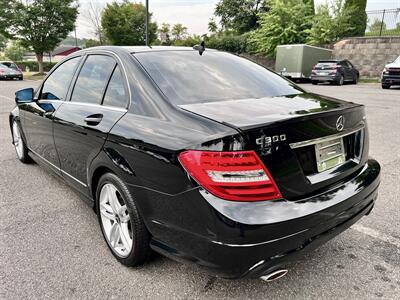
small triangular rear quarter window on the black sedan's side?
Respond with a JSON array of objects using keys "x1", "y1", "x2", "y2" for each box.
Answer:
[{"x1": 103, "y1": 66, "x2": 128, "y2": 108}]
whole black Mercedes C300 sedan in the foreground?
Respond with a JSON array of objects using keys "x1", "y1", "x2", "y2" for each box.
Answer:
[{"x1": 9, "y1": 47, "x2": 380, "y2": 280}]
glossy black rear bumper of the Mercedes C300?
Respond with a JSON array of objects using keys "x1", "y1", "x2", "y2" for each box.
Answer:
[{"x1": 145, "y1": 159, "x2": 380, "y2": 278}]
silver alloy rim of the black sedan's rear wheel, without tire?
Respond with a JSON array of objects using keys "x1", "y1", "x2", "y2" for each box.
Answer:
[{"x1": 99, "y1": 183, "x2": 133, "y2": 257}]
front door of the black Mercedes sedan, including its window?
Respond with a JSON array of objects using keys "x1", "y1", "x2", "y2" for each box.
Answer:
[{"x1": 20, "y1": 56, "x2": 81, "y2": 172}]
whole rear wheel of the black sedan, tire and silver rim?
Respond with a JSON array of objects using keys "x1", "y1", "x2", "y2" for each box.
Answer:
[{"x1": 96, "y1": 173, "x2": 151, "y2": 267}]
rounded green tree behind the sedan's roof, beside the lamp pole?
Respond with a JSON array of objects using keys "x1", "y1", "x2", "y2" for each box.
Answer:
[{"x1": 101, "y1": 0, "x2": 157, "y2": 45}]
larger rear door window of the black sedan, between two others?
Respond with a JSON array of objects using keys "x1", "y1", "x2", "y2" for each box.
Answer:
[{"x1": 71, "y1": 55, "x2": 116, "y2": 104}]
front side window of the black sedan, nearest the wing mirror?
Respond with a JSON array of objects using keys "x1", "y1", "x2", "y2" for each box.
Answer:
[{"x1": 40, "y1": 57, "x2": 80, "y2": 100}]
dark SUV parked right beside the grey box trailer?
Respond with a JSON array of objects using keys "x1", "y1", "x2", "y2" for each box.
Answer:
[{"x1": 311, "y1": 59, "x2": 360, "y2": 85}]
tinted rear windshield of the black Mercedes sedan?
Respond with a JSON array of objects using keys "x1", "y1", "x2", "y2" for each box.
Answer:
[{"x1": 135, "y1": 50, "x2": 302, "y2": 105}]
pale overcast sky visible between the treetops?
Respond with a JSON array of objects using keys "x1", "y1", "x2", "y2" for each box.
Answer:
[{"x1": 76, "y1": 0, "x2": 400, "y2": 38}]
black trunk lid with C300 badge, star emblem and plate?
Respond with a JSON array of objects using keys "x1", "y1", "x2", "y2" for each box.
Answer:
[{"x1": 179, "y1": 94, "x2": 368, "y2": 200}]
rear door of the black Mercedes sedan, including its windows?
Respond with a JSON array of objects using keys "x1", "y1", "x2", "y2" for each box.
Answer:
[{"x1": 54, "y1": 54, "x2": 129, "y2": 195}]
